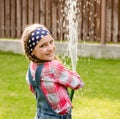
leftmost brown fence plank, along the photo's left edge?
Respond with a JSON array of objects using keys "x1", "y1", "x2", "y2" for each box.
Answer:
[{"x1": 0, "y1": 0, "x2": 5, "y2": 38}]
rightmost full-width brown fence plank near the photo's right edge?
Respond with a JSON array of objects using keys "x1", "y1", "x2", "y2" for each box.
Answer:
[{"x1": 113, "y1": 0, "x2": 118, "y2": 43}]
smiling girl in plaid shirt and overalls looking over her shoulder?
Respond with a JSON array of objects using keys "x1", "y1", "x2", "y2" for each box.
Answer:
[{"x1": 21, "y1": 24, "x2": 84, "y2": 119}]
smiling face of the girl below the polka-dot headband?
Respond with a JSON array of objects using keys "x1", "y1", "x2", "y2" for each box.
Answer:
[{"x1": 32, "y1": 35, "x2": 55, "y2": 61}]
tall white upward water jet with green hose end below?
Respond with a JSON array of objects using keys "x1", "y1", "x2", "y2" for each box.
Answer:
[{"x1": 66, "y1": 0, "x2": 78, "y2": 100}]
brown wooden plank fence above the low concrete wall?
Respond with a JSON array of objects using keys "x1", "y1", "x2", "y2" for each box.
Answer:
[{"x1": 0, "y1": 0, "x2": 120, "y2": 44}]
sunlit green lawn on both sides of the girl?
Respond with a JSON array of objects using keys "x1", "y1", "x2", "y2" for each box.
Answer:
[{"x1": 0, "y1": 52, "x2": 120, "y2": 119}]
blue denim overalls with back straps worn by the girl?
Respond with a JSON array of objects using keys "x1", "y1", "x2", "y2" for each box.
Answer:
[{"x1": 28, "y1": 64, "x2": 71, "y2": 119}]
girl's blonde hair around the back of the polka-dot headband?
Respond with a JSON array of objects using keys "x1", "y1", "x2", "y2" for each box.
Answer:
[{"x1": 21, "y1": 24, "x2": 57, "y2": 63}]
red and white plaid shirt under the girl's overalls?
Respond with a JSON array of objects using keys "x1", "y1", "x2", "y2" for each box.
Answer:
[{"x1": 26, "y1": 60, "x2": 84, "y2": 114}]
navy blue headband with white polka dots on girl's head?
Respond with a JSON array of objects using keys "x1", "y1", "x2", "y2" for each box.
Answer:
[{"x1": 27, "y1": 27, "x2": 50, "y2": 54}]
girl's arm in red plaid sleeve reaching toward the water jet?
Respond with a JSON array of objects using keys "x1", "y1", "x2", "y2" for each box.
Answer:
[{"x1": 54, "y1": 62, "x2": 84, "y2": 89}]
